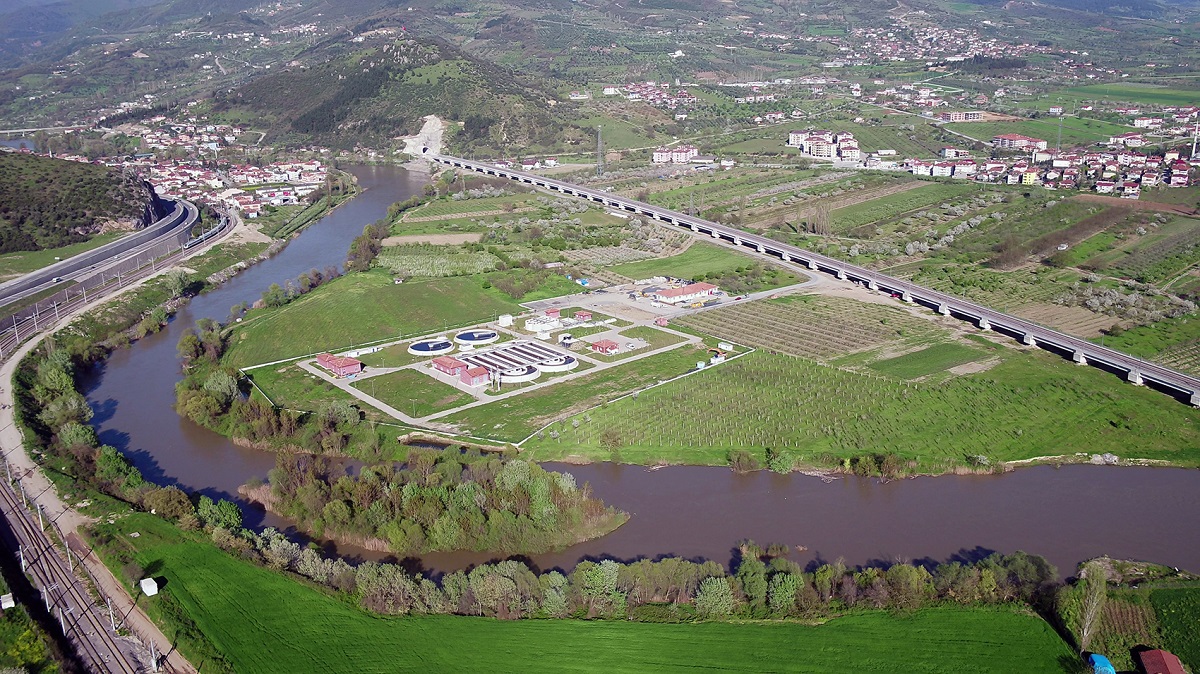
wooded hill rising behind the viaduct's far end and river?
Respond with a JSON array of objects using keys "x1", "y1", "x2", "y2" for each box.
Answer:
[{"x1": 217, "y1": 37, "x2": 560, "y2": 149}]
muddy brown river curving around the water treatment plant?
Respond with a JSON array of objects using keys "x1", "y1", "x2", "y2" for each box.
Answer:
[{"x1": 85, "y1": 161, "x2": 1200, "y2": 574}]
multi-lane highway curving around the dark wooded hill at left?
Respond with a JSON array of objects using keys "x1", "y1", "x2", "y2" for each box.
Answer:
[{"x1": 0, "y1": 200, "x2": 200, "y2": 306}]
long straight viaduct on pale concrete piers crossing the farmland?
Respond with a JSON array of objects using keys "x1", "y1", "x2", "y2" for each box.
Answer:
[{"x1": 425, "y1": 151, "x2": 1200, "y2": 407}]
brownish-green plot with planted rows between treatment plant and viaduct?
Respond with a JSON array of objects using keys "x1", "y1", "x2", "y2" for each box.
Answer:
[{"x1": 679, "y1": 296, "x2": 937, "y2": 360}]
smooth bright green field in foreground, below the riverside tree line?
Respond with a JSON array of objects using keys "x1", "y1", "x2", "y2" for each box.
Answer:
[{"x1": 91, "y1": 514, "x2": 1073, "y2": 673}]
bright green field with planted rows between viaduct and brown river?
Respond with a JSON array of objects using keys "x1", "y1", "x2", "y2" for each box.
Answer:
[{"x1": 524, "y1": 347, "x2": 1200, "y2": 473}]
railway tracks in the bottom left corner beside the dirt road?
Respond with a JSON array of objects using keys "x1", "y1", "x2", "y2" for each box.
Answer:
[{"x1": 0, "y1": 470, "x2": 150, "y2": 674}]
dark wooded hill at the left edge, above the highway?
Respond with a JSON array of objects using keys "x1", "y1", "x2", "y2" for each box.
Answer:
[{"x1": 0, "y1": 152, "x2": 150, "y2": 253}]
